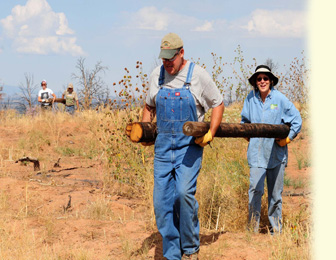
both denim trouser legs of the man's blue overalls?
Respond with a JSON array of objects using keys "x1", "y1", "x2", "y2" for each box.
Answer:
[{"x1": 153, "y1": 146, "x2": 203, "y2": 260}]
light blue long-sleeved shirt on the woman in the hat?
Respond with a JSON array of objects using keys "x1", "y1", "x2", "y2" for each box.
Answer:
[{"x1": 241, "y1": 88, "x2": 302, "y2": 169}]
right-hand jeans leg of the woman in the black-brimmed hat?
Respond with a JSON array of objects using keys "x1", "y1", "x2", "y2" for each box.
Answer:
[{"x1": 266, "y1": 163, "x2": 286, "y2": 233}]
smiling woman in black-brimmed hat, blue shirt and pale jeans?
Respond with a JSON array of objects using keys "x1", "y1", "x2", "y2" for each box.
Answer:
[{"x1": 241, "y1": 65, "x2": 302, "y2": 234}]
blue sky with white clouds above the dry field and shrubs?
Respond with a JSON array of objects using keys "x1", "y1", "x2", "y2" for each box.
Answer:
[{"x1": 0, "y1": 0, "x2": 307, "y2": 95}]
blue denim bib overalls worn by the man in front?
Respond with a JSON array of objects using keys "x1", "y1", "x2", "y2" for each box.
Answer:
[{"x1": 153, "y1": 63, "x2": 203, "y2": 260}]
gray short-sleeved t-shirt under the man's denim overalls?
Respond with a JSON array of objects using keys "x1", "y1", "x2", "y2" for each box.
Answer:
[{"x1": 146, "y1": 61, "x2": 223, "y2": 122}]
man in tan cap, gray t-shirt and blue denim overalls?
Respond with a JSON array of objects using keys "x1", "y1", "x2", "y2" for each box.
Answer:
[{"x1": 142, "y1": 33, "x2": 224, "y2": 260}]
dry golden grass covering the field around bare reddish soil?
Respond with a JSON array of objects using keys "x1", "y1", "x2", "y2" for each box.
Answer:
[{"x1": 0, "y1": 104, "x2": 311, "y2": 259}]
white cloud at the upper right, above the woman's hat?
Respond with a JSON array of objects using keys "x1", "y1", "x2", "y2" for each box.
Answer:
[{"x1": 240, "y1": 9, "x2": 306, "y2": 38}]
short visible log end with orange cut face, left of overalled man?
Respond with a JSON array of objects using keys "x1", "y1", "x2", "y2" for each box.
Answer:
[{"x1": 126, "y1": 122, "x2": 157, "y2": 143}]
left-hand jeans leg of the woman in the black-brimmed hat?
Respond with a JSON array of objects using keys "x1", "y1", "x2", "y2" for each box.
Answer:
[{"x1": 248, "y1": 168, "x2": 266, "y2": 232}]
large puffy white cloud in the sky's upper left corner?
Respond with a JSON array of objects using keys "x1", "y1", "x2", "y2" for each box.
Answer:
[{"x1": 0, "y1": 0, "x2": 84, "y2": 56}]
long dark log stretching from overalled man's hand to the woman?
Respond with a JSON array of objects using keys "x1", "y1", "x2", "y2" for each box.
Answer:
[{"x1": 183, "y1": 121, "x2": 289, "y2": 139}]
